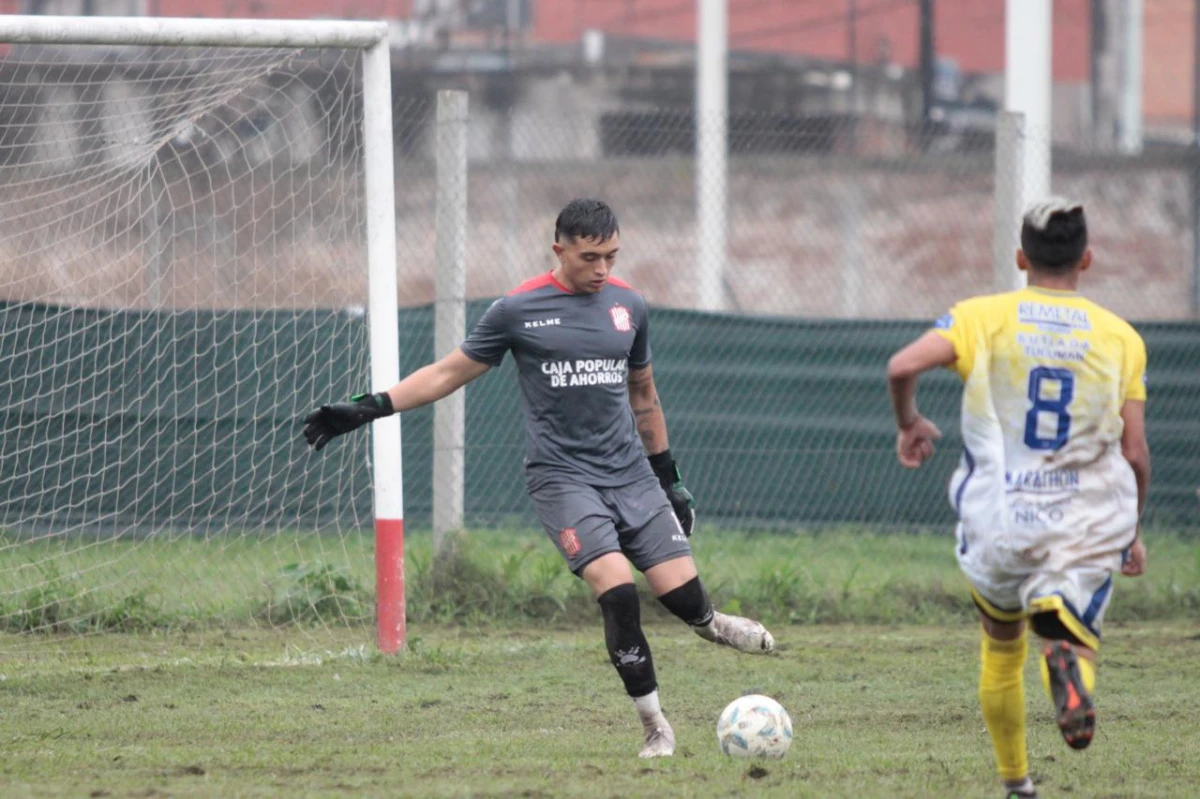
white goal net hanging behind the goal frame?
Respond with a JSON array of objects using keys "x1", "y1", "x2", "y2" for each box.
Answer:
[{"x1": 0, "y1": 19, "x2": 400, "y2": 645}]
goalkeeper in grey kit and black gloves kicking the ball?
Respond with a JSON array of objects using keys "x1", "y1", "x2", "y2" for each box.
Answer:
[{"x1": 304, "y1": 199, "x2": 775, "y2": 757}]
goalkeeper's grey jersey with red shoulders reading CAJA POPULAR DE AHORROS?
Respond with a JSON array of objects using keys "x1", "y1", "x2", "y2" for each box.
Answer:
[{"x1": 462, "y1": 272, "x2": 653, "y2": 491}]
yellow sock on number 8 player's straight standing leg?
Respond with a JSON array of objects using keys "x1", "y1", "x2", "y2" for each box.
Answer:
[{"x1": 979, "y1": 632, "x2": 1030, "y2": 781}]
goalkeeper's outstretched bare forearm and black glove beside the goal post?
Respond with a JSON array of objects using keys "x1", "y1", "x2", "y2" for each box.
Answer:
[{"x1": 304, "y1": 349, "x2": 490, "y2": 450}]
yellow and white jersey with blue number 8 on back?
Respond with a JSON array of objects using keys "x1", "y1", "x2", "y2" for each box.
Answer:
[{"x1": 934, "y1": 287, "x2": 1146, "y2": 547}]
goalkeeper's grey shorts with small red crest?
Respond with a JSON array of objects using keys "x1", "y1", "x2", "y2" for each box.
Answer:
[{"x1": 529, "y1": 475, "x2": 691, "y2": 575}]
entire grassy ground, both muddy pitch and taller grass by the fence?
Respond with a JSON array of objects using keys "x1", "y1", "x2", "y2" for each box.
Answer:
[{"x1": 0, "y1": 531, "x2": 1200, "y2": 797}]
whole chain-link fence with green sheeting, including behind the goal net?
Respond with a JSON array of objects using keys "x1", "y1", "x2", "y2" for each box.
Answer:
[{"x1": 0, "y1": 59, "x2": 1200, "y2": 544}]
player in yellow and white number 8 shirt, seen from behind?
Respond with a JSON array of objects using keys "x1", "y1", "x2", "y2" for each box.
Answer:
[{"x1": 888, "y1": 198, "x2": 1150, "y2": 798}]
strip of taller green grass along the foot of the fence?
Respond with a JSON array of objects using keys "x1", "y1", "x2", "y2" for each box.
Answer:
[{"x1": 0, "y1": 530, "x2": 1200, "y2": 633}]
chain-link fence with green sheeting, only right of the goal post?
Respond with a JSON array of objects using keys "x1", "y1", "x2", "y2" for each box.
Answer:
[{"x1": 398, "y1": 99, "x2": 1200, "y2": 528}]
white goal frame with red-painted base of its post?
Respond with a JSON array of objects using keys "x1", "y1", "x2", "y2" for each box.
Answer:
[{"x1": 0, "y1": 16, "x2": 406, "y2": 653}]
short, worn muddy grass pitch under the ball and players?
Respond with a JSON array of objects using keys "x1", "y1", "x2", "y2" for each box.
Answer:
[{"x1": 0, "y1": 623, "x2": 1200, "y2": 797}]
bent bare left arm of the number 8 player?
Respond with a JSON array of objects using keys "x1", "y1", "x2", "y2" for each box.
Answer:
[{"x1": 888, "y1": 331, "x2": 955, "y2": 469}]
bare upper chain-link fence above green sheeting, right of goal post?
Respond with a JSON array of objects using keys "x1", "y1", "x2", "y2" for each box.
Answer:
[{"x1": 397, "y1": 103, "x2": 1195, "y2": 320}]
